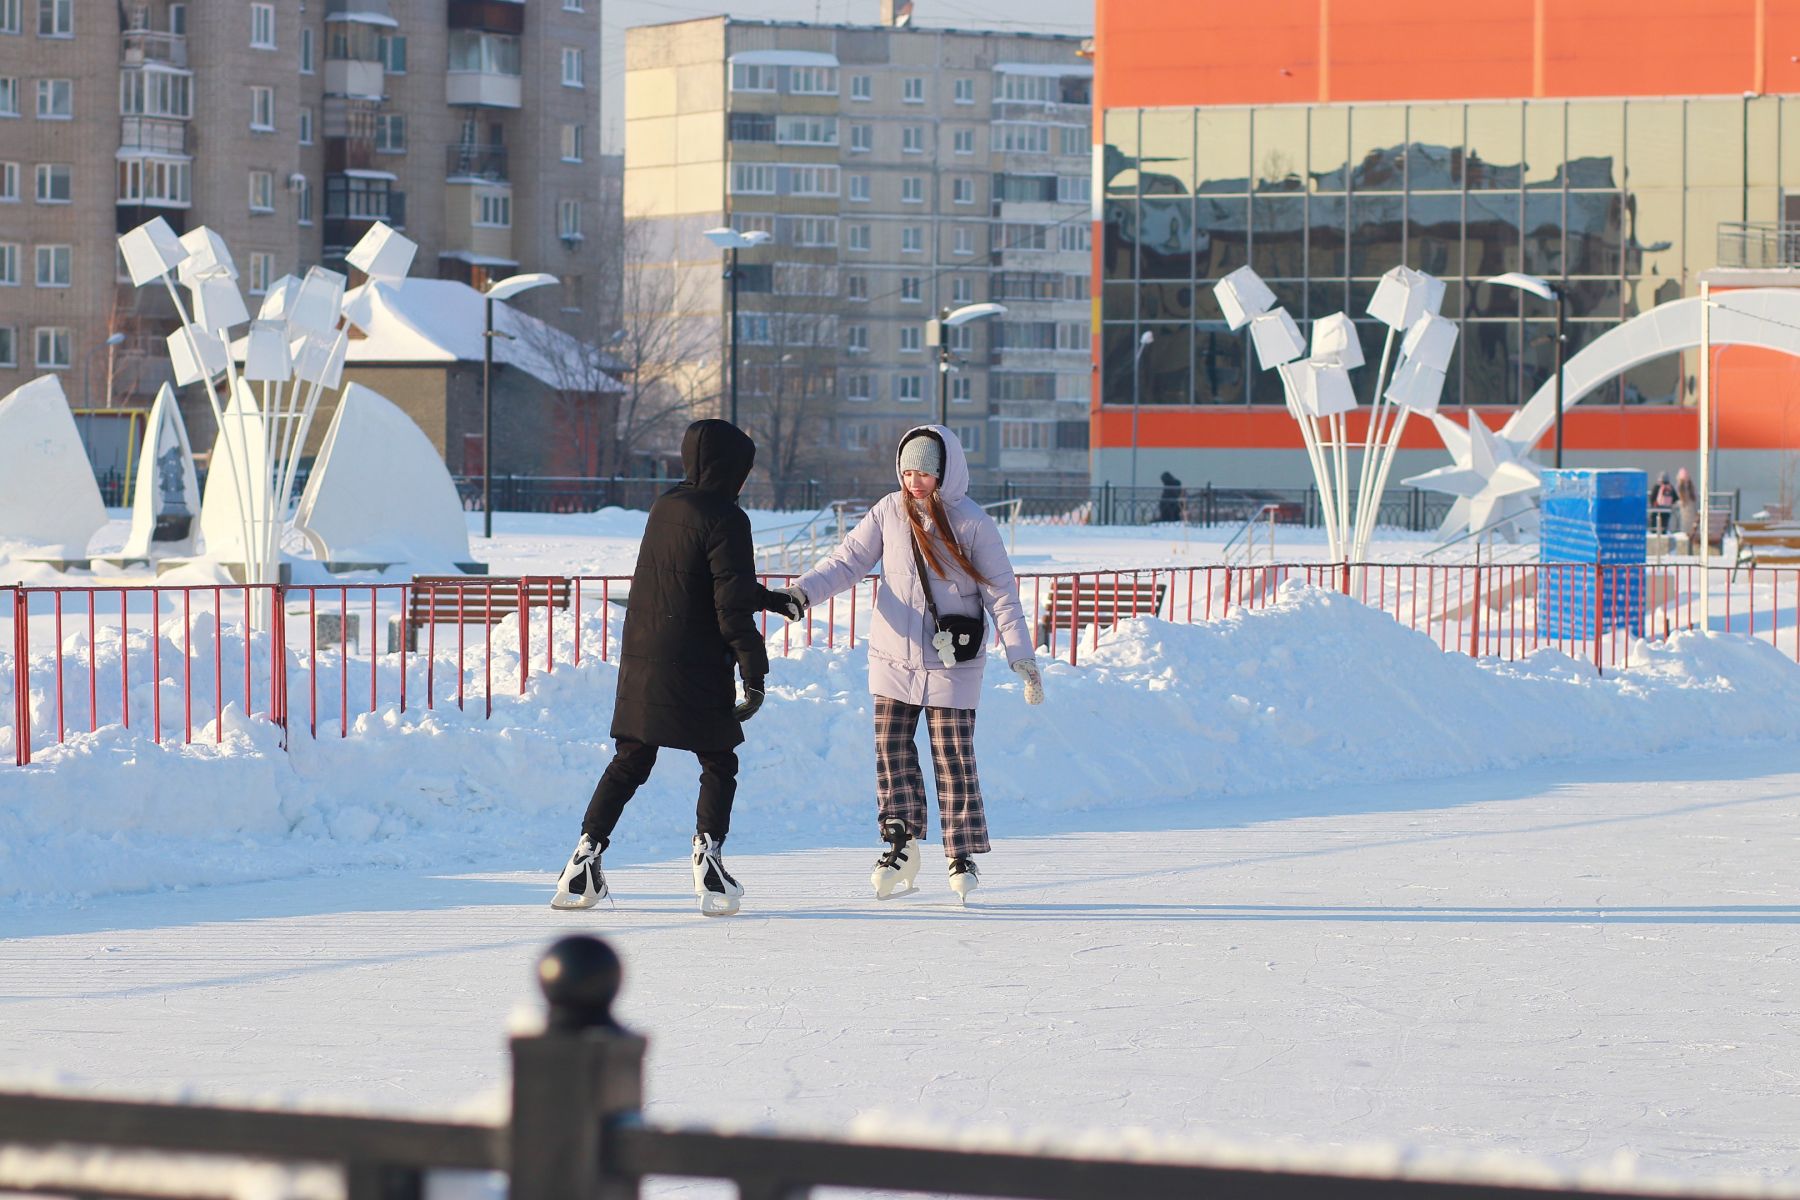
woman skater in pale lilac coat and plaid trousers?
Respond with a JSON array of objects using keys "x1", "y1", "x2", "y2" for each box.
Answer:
[{"x1": 783, "y1": 425, "x2": 1044, "y2": 900}]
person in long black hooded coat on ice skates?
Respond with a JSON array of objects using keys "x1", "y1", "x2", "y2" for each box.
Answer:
[{"x1": 551, "y1": 421, "x2": 790, "y2": 916}]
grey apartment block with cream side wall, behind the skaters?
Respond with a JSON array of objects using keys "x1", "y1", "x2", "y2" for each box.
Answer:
[{"x1": 625, "y1": 5, "x2": 1093, "y2": 488}]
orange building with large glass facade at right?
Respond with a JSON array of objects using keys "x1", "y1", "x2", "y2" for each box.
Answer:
[{"x1": 1091, "y1": 0, "x2": 1800, "y2": 506}]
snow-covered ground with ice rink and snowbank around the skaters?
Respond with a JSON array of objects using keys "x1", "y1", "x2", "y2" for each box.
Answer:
[{"x1": 0, "y1": 513, "x2": 1800, "y2": 1184}]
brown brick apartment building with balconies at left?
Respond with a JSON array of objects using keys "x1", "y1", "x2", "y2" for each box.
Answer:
[{"x1": 0, "y1": 0, "x2": 616, "y2": 448}]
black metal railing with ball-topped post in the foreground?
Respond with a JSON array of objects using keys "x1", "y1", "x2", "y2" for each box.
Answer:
[{"x1": 0, "y1": 936, "x2": 1750, "y2": 1200}]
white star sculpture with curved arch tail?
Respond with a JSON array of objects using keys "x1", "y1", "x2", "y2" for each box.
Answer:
[{"x1": 1402, "y1": 288, "x2": 1800, "y2": 538}]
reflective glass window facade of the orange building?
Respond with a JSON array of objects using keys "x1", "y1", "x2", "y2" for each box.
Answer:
[{"x1": 1100, "y1": 97, "x2": 1800, "y2": 407}]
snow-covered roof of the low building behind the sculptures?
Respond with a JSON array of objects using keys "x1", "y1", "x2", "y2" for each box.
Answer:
[{"x1": 344, "y1": 279, "x2": 625, "y2": 392}]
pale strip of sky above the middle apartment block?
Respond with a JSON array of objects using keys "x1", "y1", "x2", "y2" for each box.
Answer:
[{"x1": 601, "y1": 0, "x2": 1094, "y2": 153}]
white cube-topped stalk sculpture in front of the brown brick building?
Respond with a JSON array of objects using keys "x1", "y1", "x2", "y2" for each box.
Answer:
[{"x1": 119, "y1": 218, "x2": 416, "y2": 600}]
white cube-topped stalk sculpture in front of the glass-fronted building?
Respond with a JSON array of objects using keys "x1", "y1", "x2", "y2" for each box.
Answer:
[{"x1": 1213, "y1": 266, "x2": 1456, "y2": 561}]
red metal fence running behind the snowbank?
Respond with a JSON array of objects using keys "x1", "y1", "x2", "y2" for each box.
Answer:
[{"x1": 0, "y1": 563, "x2": 1800, "y2": 765}]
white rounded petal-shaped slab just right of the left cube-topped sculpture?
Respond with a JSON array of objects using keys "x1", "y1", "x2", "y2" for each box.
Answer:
[{"x1": 293, "y1": 383, "x2": 470, "y2": 569}]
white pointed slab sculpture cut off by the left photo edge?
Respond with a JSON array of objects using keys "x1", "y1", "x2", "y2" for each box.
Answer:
[{"x1": 0, "y1": 374, "x2": 106, "y2": 560}]
